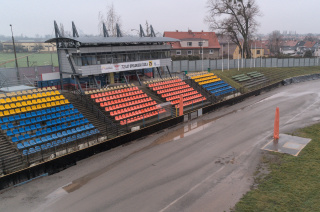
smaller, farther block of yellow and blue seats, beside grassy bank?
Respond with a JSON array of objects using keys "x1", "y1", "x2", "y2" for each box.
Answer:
[{"x1": 188, "y1": 72, "x2": 236, "y2": 97}]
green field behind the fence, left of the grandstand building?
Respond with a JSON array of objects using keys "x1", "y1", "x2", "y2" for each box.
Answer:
[{"x1": 0, "y1": 52, "x2": 58, "y2": 68}]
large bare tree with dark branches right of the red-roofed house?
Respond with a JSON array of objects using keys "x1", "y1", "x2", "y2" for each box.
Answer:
[{"x1": 205, "y1": 0, "x2": 261, "y2": 58}]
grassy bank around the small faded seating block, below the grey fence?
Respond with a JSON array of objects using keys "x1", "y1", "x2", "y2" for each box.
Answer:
[{"x1": 211, "y1": 66, "x2": 320, "y2": 91}]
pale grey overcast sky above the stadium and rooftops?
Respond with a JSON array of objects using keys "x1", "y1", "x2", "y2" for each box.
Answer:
[{"x1": 0, "y1": 0, "x2": 320, "y2": 36}]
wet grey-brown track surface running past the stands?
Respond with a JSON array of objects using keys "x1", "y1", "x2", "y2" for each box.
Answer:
[{"x1": 0, "y1": 81, "x2": 320, "y2": 212}]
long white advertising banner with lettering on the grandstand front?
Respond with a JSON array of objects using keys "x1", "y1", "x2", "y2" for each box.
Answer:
[{"x1": 101, "y1": 60, "x2": 160, "y2": 73}]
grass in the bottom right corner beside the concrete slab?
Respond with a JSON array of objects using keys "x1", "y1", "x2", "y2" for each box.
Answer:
[{"x1": 234, "y1": 124, "x2": 320, "y2": 212}]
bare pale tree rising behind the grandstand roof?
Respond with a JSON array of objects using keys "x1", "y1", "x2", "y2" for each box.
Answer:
[{"x1": 98, "y1": 3, "x2": 121, "y2": 36}]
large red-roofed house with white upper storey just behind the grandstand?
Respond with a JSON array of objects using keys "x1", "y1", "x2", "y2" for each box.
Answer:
[{"x1": 163, "y1": 30, "x2": 220, "y2": 59}]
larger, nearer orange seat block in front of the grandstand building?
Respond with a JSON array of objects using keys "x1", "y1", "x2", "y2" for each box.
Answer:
[{"x1": 87, "y1": 85, "x2": 166, "y2": 125}]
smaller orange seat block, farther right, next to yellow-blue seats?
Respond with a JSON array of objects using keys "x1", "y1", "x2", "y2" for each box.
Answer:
[{"x1": 146, "y1": 77, "x2": 206, "y2": 107}]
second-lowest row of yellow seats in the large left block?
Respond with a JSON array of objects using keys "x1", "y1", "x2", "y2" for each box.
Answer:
[{"x1": 0, "y1": 95, "x2": 65, "y2": 110}]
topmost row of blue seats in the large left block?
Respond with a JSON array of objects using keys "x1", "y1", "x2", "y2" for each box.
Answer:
[{"x1": 0, "y1": 104, "x2": 74, "y2": 124}]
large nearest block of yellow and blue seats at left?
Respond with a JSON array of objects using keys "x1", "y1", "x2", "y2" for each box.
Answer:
[{"x1": 0, "y1": 87, "x2": 100, "y2": 155}]
